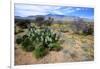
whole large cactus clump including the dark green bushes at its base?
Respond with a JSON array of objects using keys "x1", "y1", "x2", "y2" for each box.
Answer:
[{"x1": 18, "y1": 27, "x2": 61, "y2": 58}]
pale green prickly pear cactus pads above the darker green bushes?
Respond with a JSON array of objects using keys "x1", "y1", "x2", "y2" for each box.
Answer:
[{"x1": 28, "y1": 28, "x2": 59, "y2": 48}]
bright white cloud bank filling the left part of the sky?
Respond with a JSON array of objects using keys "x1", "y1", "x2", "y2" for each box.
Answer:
[{"x1": 15, "y1": 4, "x2": 60, "y2": 16}]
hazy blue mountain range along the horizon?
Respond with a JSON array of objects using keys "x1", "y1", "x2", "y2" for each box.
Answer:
[{"x1": 15, "y1": 14, "x2": 94, "y2": 22}]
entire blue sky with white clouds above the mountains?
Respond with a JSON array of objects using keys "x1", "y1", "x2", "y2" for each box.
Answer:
[{"x1": 14, "y1": 4, "x2": 94, "y2": 19}]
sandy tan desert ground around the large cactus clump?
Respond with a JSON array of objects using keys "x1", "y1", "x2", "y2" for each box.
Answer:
[{"x1": 14, "y1": 22, "x2": 94, "y2": 65}]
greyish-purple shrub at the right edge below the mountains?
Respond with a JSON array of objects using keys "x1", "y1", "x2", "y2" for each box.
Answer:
[{"x1": 72, "y1": 20, "x2": 94, "y2": 35}]
